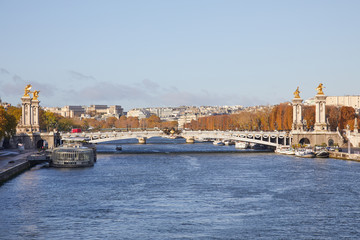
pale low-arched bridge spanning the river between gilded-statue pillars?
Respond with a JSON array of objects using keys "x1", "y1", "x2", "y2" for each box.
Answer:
[{"x1": 61, "y1": 131, "x2": 291, "y2": 147}]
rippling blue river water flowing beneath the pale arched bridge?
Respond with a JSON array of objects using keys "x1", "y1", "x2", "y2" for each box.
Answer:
[{"x1": 0, "y1": 138, "x2": 360, "y2": 239}]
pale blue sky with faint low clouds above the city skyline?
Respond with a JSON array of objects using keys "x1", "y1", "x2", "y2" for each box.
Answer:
[{"x1": 0, "y1": 0, "x2": 360, "y2": 110}]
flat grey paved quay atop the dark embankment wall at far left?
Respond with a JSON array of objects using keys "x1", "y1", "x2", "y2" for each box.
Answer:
[{"x1": 0, "y1": 150, "x2": 34, "y2": 185}]
